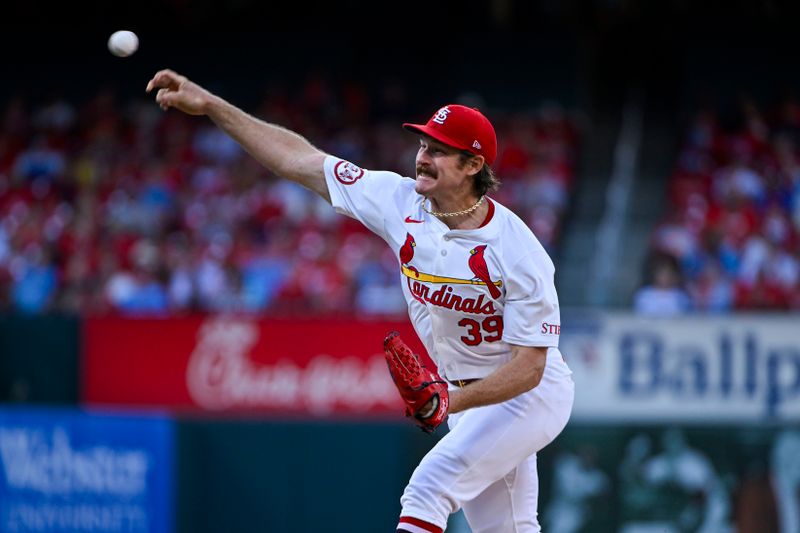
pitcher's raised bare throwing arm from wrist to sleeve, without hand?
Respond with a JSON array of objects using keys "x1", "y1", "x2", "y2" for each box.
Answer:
[{"x1": 205, "y1": 96, "x2": 330, "y2": 201}]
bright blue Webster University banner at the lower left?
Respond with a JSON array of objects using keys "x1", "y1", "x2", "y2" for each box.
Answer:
[{"x1": 0, "y1": 408, "x2": 173, "y2": 533}]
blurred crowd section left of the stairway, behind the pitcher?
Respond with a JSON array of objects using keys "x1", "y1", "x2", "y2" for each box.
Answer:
[{"x1": 0, "y1": 80, "x2": 578, "y2": 315}]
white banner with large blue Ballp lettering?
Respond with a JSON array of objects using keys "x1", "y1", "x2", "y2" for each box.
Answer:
[{"x1": 561, "y1": 314, "x2": 800, "y2": 423}]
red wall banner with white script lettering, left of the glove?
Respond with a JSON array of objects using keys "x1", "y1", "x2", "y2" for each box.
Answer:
[{"x1": 83, "y1": 317, "x2": 427, "y2": 417}]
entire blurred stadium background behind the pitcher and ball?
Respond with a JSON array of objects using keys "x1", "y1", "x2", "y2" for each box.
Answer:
[{"x1": 0, "y1": 0, "x2": 800, "y2": 533}]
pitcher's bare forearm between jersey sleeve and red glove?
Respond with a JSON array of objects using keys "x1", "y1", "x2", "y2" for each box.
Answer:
[{"x1": 448, "y1": 344, "x2": 547, "y2": 413}]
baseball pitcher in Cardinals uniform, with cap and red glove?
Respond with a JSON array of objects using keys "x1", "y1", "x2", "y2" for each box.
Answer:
[{"x1": 147, "y1": 70, "x2": 574, "y2": 533}]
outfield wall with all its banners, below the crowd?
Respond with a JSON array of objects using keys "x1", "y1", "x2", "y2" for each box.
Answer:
[{"x1": 0, "y1": 313, "x2": 800, "y2": 533}]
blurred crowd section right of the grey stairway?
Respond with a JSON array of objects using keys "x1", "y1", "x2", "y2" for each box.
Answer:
[{"x1": 634, "y1": 98, "x2": 800, "y2": 314}]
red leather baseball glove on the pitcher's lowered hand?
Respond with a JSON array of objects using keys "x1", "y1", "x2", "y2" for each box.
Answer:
[{"x1": 383, "y1": 331, "x2": 450, "y2": 433}]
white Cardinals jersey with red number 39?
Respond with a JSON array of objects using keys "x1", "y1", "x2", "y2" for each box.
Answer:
[{"x1": 325, "y1": 156, "x2": 561, "y2": 381}]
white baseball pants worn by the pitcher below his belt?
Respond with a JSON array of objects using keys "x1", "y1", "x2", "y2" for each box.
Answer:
[{"x1": 400, "y1": 349, "x2": 575, "y2": 533}]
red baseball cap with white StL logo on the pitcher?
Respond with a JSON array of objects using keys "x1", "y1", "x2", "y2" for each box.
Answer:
[{"x1": 403, "y1": 104, "x2": 497, "y2": 166}]
